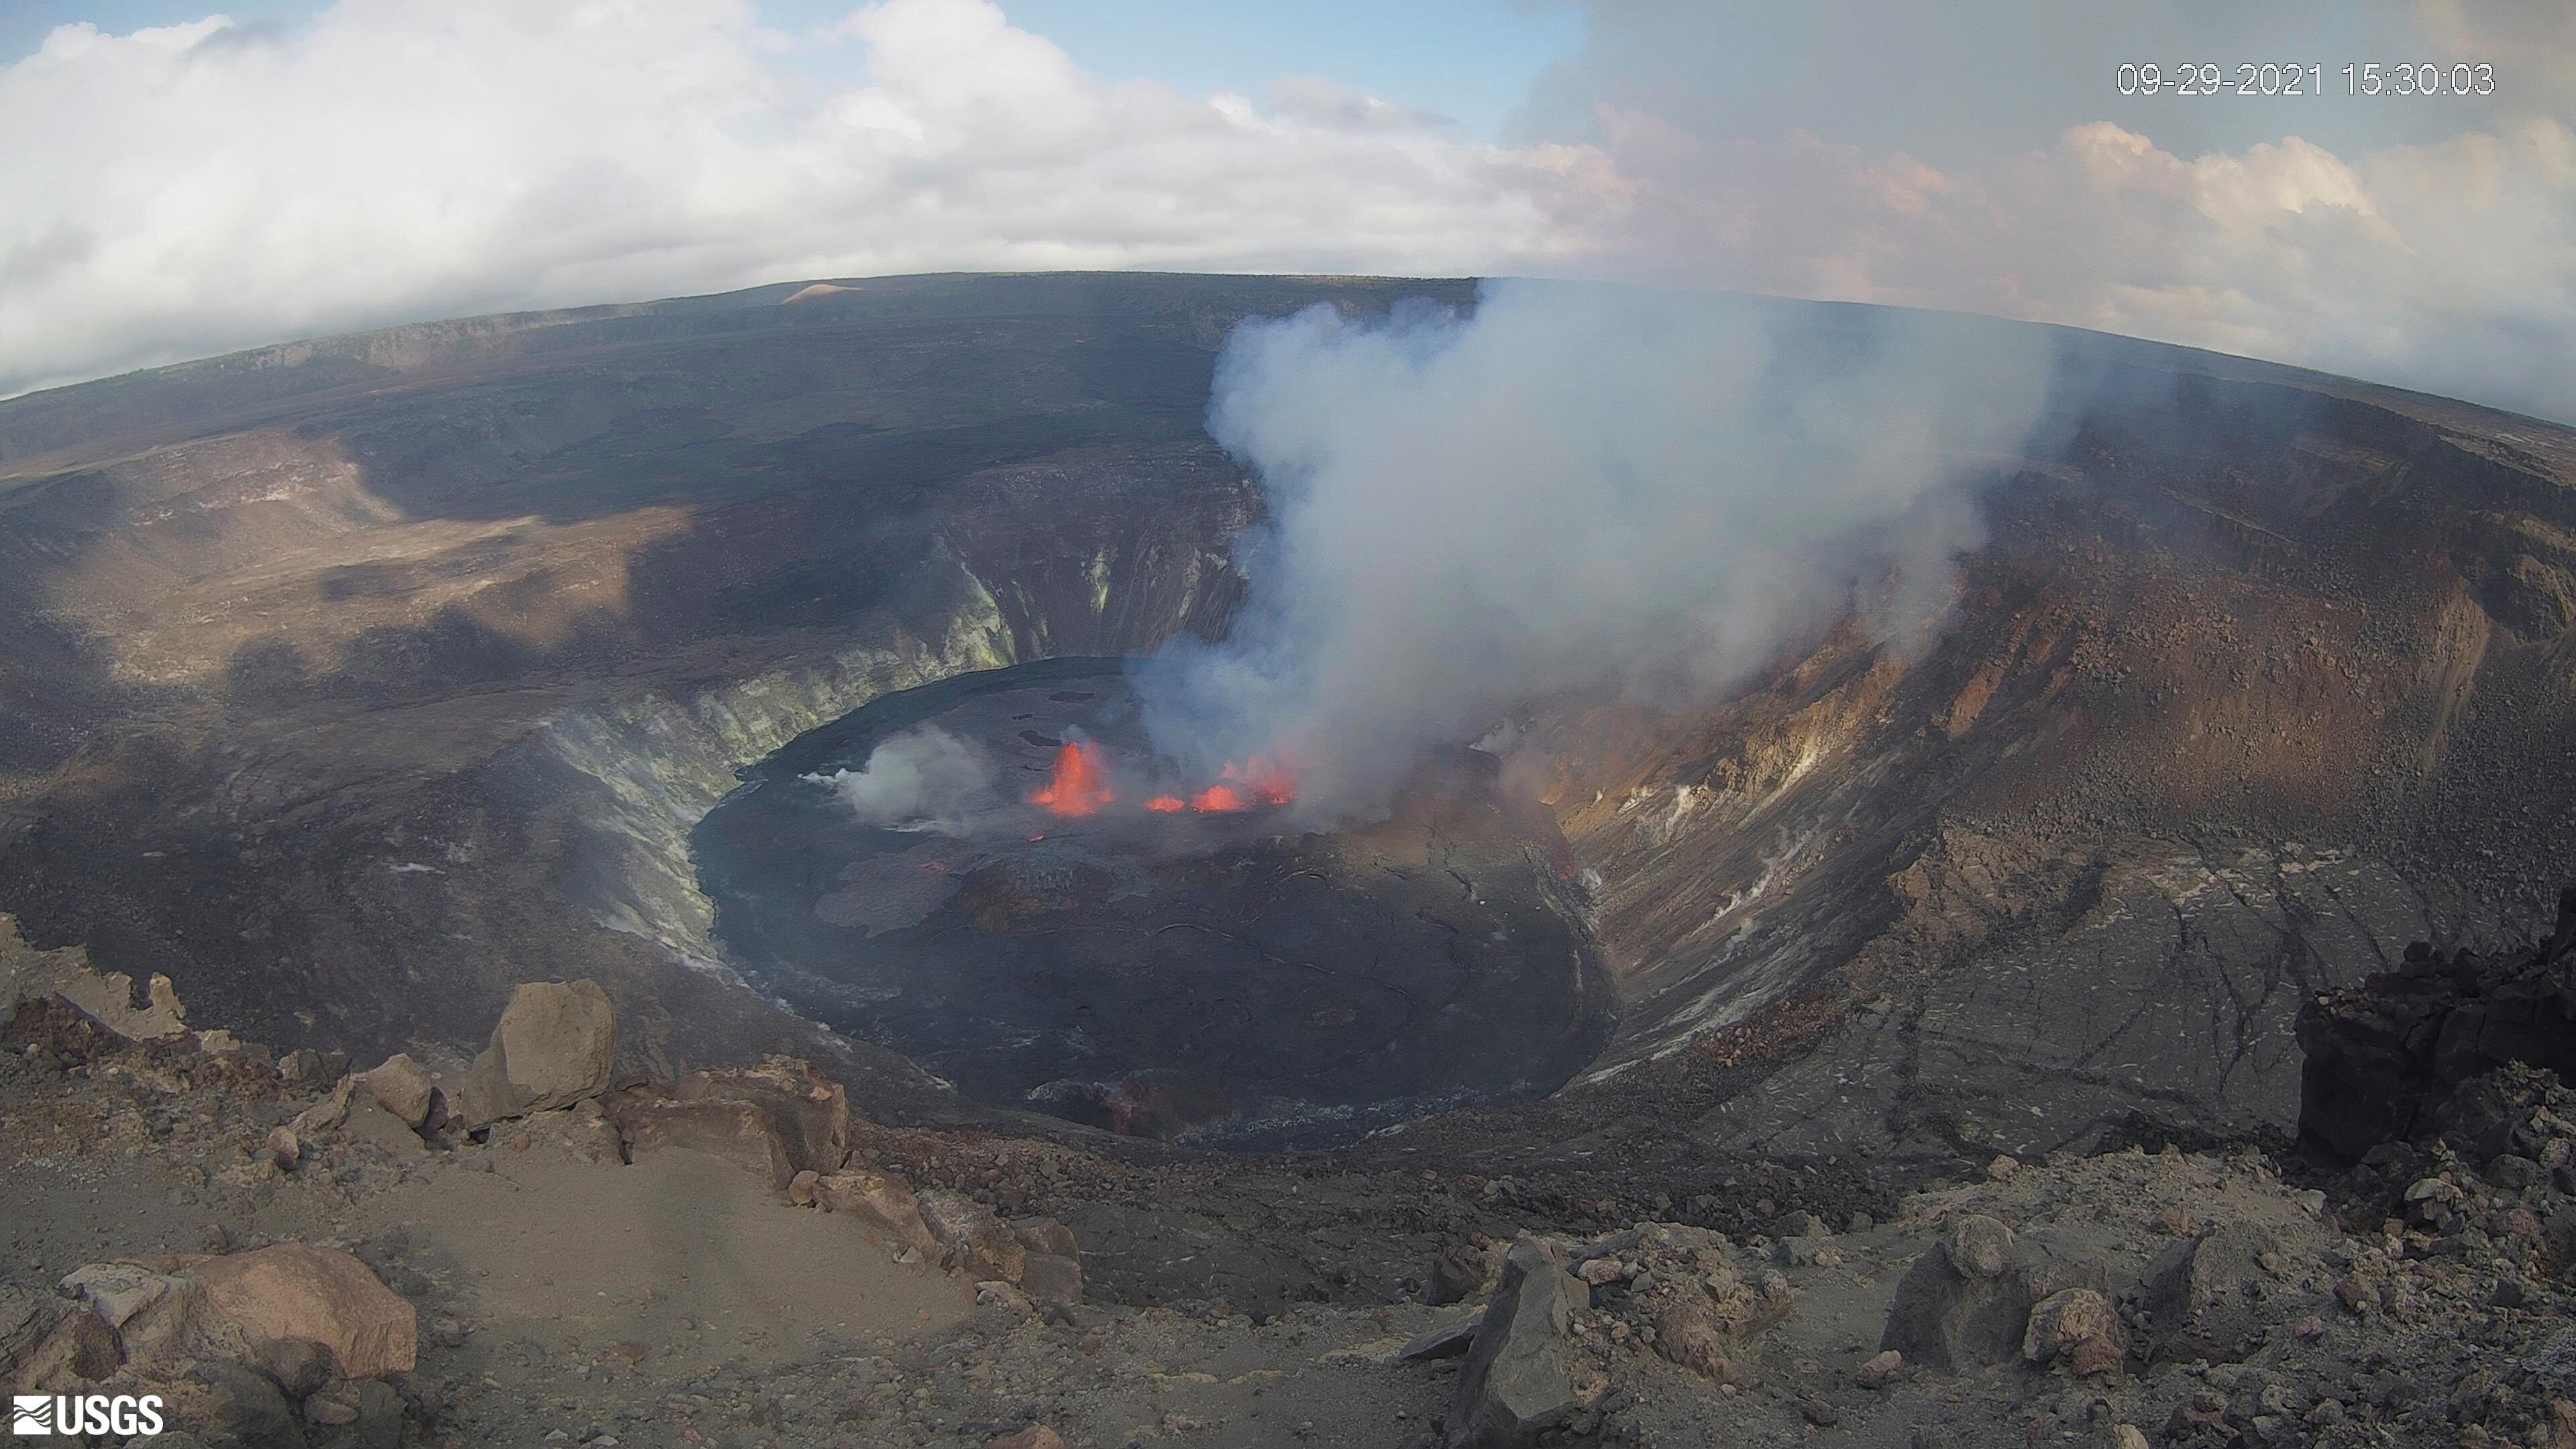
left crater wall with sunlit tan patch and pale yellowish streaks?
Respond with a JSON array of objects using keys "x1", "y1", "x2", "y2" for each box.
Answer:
[{"x1": 0, "y1": 278, "x2": 1339, "y2": 1075}]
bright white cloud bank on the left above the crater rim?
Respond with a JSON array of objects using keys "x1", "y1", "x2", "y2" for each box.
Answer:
[{"x1": 0, "y1": 0, "x2": 1579, "y2": 392}]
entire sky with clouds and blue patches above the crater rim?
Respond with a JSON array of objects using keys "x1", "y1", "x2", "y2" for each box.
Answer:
[{"x1": 15, "y1": 0, "x2": 2576, "y2": 420}]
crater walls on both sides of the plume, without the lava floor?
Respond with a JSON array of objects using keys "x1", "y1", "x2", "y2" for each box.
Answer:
[{"x1": 0, "y1": 276, "x2": 2576, "y2": 1155}]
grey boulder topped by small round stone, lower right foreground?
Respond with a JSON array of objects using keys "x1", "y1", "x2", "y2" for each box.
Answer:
[{"x1": 1878, "y1": 1217, "x2": 2107, "y2": 1375}]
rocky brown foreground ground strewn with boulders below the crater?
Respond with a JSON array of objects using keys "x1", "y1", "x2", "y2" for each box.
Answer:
[{"x1": 0, "y1": 900, "x2": 2576, "y2": 1449}]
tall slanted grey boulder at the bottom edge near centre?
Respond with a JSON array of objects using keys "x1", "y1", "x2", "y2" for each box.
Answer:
[{"x1": 1450, "y1": 1238, "x2": 1587, "y2": 1449}]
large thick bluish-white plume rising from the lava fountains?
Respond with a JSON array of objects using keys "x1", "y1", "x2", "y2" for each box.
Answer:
[{"x1": 1136, "y1": 281, "x2": 2051, "y2": 822}]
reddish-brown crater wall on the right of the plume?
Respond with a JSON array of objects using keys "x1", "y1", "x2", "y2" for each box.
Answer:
[{"x1": 1494, "y1": 337, "x2": 2576, "y2": 1155}]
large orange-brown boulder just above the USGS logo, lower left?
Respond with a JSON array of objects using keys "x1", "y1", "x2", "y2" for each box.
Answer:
[{"x1": 188, "y1": 1243, "x2": 420, "y2": 1379}]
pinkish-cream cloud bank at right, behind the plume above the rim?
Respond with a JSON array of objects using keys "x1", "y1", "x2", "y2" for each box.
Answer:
[{"x1": 1566, "y1": 111, "x2": 2576, "y2": 418}]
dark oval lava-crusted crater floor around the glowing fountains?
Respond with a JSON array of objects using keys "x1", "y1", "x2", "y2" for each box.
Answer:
[{"x1": 693, "y1": 660, "x2": 1610, "y2": 1147}]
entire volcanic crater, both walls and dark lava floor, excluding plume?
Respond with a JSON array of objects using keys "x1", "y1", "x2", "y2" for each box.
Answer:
[{"x1": 0, "y1": 276, "x2": 2576, "y2": 1175}]
